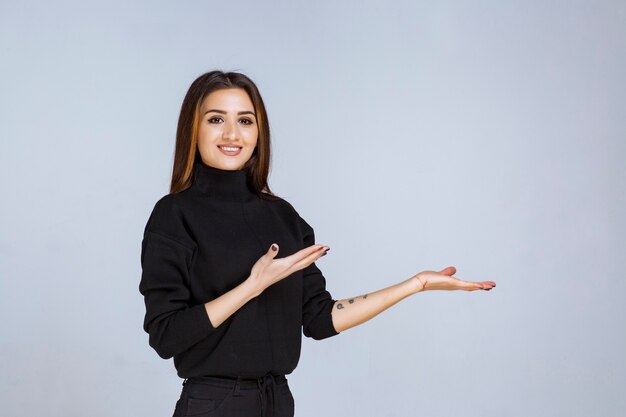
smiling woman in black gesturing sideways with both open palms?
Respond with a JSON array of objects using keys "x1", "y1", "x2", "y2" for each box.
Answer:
[{"x1": 139, "y1": 71, "x2": 495, "y2": 417}]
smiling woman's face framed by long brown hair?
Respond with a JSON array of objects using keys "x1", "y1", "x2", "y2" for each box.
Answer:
[{"x1": 198, "y1": 88, "x2": 259, "y2": 170}]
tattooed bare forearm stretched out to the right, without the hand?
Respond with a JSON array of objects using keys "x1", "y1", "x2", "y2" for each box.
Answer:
[{"x1": 332, "y1": 278, "x2": 421, "y2": 332}]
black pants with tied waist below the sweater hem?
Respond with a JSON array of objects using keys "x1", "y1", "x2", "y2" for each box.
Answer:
[{"x1": 173, "y1": 374, "x2": 295, "y2": 417}]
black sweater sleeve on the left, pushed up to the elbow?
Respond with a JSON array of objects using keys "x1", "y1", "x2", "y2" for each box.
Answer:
[{"x1": 139, "y1": 200, "x2": 215, "y2": 359}]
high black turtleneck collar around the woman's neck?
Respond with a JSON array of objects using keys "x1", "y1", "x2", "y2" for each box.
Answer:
[{"x1": 193, "y1": 161, "x2": 256, "y2": 201}]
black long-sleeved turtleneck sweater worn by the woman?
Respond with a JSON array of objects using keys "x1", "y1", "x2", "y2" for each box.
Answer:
[{"x1": 139, "y1": 163, "x2": 338, "y2": 378}]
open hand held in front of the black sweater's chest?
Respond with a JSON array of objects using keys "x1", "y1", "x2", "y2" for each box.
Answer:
[{"x1": 248, "y1": 243, "x2": 330, "y2": 296}]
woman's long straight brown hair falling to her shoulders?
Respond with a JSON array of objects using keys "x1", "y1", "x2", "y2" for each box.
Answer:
[{"x1": 170, "y1": 71, "x2": 279, "y2": 200}]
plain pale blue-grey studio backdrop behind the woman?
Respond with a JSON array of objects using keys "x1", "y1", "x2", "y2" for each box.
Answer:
[{"x1": 0, "y1": 0, "x2": 626, "y2": 417}]
